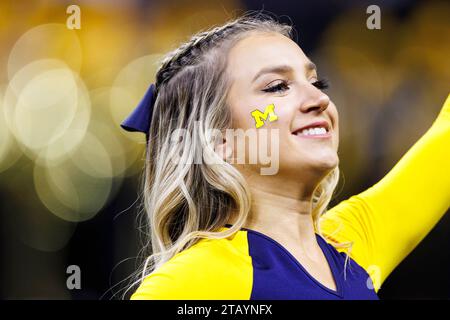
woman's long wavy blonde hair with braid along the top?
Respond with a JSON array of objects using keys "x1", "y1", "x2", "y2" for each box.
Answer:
[{"x1": 122, "y1": 12, "x2": 339, "y2": 298}]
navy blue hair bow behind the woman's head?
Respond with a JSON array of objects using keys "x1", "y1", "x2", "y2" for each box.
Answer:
[{"x1": 120, "y1": 83, "x2": 156, "y2": 142}]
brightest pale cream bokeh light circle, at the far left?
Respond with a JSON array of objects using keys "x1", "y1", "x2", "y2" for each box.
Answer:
[{"x1": 3, "y1": 59, "x2": 90, "y2": 165}]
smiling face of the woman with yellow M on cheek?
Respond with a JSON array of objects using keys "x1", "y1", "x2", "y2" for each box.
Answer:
[{"x1": 227, "y1": 33, "x2": 339, "y2": 178}]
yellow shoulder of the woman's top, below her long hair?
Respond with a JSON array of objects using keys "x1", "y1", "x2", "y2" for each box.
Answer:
[{"x1": 131, "y1": 231, "x2": 252, "y2": 300}]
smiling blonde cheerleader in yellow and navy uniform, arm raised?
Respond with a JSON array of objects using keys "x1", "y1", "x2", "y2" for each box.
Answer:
[{"x1": 122, "y1": 14, "x2": 450, "y2": 299}]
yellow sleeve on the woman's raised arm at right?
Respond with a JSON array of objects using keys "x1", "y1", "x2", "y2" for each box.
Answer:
[{"x1": 320, "y1": 95, "x2": 450, "y2": 291}]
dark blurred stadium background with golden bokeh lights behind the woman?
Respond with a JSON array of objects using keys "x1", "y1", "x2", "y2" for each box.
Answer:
[{"x1": 0, "y1": 0, "x2": 450, "y2": 299}]
